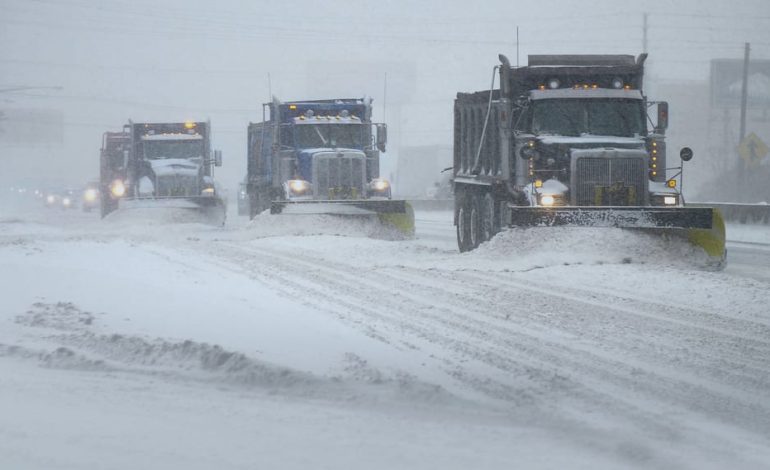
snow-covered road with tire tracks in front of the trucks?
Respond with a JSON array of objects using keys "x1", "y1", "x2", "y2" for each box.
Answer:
[{"x1": 0, "y1": 200, "x2": 770, "y2": 469}]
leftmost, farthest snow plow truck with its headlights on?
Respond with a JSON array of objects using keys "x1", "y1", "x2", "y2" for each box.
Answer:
[{"x1": 100, "y1": 121, "x2": 226, "y2": 225}]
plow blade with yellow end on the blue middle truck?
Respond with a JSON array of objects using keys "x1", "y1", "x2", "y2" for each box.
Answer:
[{"x1": 270, "y1": 199, "x2": 414, "y2": 237}]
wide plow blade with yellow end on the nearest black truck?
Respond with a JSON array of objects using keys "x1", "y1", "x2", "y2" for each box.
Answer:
[{"x1": 510, "y1": 206, "x2": 726, "y2": 269}]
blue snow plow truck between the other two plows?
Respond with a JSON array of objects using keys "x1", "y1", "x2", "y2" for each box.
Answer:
[{"x1": 246, "y1": 98, "x2": 414, "y2": 236}]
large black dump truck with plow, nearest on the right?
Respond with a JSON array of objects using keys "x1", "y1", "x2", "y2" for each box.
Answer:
[{"x1": 453, "y1": 54, "x2": 725, "y2": 267}]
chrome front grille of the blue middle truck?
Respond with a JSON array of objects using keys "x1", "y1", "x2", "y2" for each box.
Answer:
[{"x1": 314, "y1": 154, "x2": 366, "y2": 199}]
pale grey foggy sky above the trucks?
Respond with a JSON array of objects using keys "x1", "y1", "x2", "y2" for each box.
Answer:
[{"x1": 0, "y1": 0, "x2": 770, "y2": 195}]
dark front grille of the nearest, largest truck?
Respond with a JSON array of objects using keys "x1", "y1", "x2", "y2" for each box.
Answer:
[{"x1": 572, "y1": 150, "x2": 649, "y2": 206}]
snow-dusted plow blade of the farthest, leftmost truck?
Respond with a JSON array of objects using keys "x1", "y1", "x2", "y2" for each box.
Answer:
[{"x1": 112, "y1": 196, "x2": 227, "y2": 225}]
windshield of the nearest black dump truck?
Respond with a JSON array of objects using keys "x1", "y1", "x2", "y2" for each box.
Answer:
[{"x1": 532, "y1": 99, "x2": 645, "y2": 137}]
